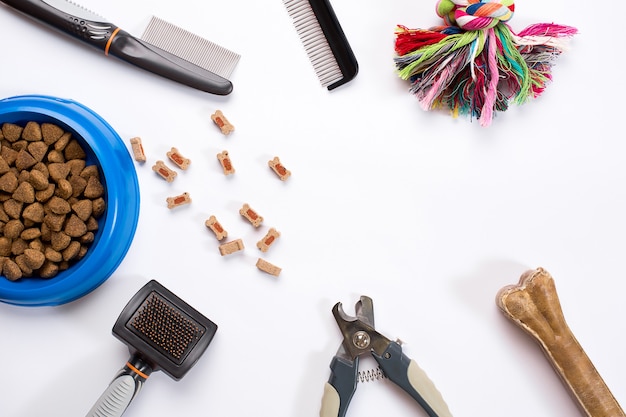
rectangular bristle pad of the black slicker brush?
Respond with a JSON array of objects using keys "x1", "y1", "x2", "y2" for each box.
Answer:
[{"x1": 128, "y1": 292, "x2": 205, "y2": 362}]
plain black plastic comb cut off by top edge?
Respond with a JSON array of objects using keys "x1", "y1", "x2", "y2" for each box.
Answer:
[{"x1": 283, "y1": 0, "x2": 359, "y2": 90}]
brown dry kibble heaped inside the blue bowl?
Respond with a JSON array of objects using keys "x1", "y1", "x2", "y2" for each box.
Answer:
[{"x1": 0, "y1": 121, "x2": 106, "y2": 281}]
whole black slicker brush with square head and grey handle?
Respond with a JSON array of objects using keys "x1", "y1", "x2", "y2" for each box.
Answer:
[{"x1": 87, "y1": 280, "x2": 217, "y2": 417}]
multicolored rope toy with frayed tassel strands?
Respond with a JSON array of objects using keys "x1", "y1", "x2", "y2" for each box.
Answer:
[{"x1": 394, "y1": 0, "x2": 577, "y2": 126}]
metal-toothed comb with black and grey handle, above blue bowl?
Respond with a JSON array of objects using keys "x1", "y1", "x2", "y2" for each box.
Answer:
[{"x1": 0, "y1": 0, "x2": 240, "y2": 95}]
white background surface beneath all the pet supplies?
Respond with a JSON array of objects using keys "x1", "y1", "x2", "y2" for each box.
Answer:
[{"x1": 0, "y1": 0, "x2": 626, "y2": 417}]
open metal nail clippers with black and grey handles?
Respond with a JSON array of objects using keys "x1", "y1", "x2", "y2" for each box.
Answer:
[{"x1": 320, "y1": 296, "x2": 452, "y2": 417}]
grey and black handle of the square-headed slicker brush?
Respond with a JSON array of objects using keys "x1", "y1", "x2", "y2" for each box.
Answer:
[{"x1": 87, "y1": 357, "x2": 152, "y2": 417}]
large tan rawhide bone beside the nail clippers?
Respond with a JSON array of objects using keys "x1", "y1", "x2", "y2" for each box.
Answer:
[{"x1": 496, "y1": 268, "x2": 625, "y2": 417}]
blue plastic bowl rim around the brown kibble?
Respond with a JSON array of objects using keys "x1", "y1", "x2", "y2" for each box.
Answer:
[{"x1": 0, "y1": 95, "x2": 139, "y2": 306}]
